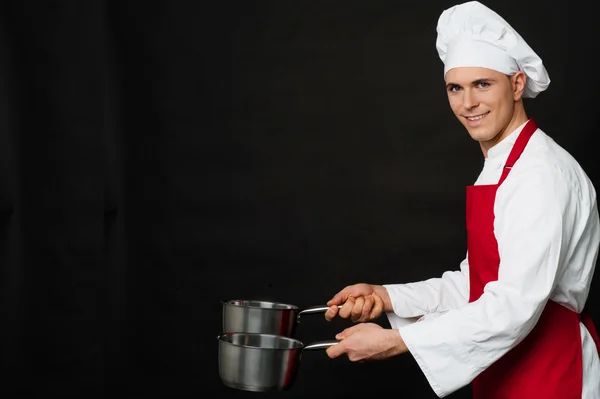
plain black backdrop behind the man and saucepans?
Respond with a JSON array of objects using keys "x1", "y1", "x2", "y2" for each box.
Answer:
[{"x1": 0, "y1": 0, "x2": 600, "y2": 398}]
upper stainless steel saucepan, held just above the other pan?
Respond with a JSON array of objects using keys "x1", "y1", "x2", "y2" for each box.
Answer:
[{"x1": 222, "y1": 300, "x2": 340, "y2": 337}]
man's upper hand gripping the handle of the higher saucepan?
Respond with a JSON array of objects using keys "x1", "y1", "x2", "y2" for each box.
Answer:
[{"x1": 325, "y1": 283, "x2": 391, "y2": 323}]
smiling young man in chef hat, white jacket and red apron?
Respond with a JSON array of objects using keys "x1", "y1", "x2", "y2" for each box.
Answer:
[{"x1": 325, "y1": 2, "x2": 600, "y2": 399}]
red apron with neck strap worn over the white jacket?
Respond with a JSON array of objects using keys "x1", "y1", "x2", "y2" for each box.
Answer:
[{"x1": 466, "y1": 119, "x2": 600, "y2": 399}]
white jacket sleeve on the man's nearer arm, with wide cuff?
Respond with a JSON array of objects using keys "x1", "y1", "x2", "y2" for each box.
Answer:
[{"x1": 399, "y1": 167, "x2": 587, "y2": 397}]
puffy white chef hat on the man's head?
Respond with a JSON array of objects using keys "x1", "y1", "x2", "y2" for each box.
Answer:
[{"x1": 436, "y1": 1, "x2": 550, "y2": 98}]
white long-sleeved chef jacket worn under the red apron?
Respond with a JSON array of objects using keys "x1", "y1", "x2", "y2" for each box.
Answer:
[{"x1": 384, "y1": 124, "x2": 600, "y2": 399}]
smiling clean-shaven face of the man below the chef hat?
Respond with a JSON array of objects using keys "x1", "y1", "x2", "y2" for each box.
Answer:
[{"x1": 446, "y1": 67, "x2": 520, "y2": 145}]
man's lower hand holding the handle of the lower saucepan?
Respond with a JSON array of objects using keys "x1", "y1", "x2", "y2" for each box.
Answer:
[{"x1": 327, "y1": 323, "x2": 408, "y2": 362}]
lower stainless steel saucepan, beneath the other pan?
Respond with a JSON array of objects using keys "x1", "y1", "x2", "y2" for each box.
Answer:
[{"x1": 217, "y1": 333, "x2": 338, "y2": 392}]
